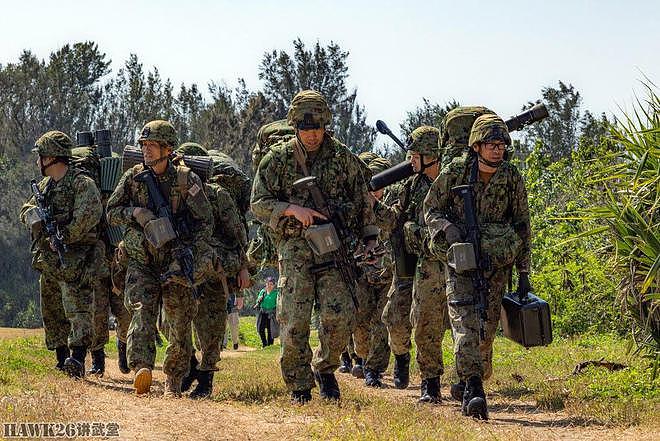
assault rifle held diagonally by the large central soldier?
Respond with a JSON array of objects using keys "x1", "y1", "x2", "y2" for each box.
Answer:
[{"x1": 293, "y1": 176, "x2": 360, "y2": 308}]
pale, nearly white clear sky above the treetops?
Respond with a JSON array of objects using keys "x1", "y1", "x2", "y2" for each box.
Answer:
[{"x1": 0, "y1": 0, "x2": 660, "y2": 140}]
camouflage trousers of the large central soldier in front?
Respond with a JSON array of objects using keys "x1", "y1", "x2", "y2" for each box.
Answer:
[{"x1": 277, "y1": 238, "x2": 355, "y2": 390}]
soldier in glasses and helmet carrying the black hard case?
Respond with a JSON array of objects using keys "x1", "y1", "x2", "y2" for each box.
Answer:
[{"x1": 424, "y1": 114, "x2": 530, "y2": 419}]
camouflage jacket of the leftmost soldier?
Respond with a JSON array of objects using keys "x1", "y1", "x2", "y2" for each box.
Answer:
[{"x1": 20, "y1": 167, "x2": 103, "y2": 271}]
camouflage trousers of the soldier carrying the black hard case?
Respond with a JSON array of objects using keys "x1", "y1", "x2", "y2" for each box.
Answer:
[{"x1": 447, "y1": 267, "x2": 511, "y2": 380}]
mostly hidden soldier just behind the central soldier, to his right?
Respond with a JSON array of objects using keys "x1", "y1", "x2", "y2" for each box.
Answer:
[{"x1": 353, "y1": 153, "x2": 392, "y2": 387}]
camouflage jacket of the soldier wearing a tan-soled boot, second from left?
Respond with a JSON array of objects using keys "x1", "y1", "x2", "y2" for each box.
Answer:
[{"x1": 107, "y1": 162, "x2": 213, "y2": 269}]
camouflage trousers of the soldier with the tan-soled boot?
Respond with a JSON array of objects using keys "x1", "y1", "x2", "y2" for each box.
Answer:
[{"x1": 124, "y1": 261, "x2": 197, "y2": 379}]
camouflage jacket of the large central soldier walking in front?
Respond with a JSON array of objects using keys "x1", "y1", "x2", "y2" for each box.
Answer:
[{"x1": 251, "y1": 134, "x2": 378, "y2": 242}]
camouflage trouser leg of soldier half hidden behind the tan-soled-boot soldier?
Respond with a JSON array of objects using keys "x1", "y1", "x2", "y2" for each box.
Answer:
[{"x1": 193, "y1": 281, "x2": 227, "y2": 371}]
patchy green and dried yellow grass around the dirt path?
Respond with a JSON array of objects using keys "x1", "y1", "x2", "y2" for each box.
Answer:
[{"x1": 0, "y1": 326, "x2": 660, "y2": 439}]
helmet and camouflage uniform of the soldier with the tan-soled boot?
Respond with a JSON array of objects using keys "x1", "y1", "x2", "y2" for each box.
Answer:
[{"x1": 107, "y1": 121, "x2": 213, "y2": 393}]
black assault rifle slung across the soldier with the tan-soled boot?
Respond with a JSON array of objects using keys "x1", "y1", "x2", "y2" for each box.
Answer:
[{"x1": 133, "y1": 168, "x2": 199, "y2": 300}]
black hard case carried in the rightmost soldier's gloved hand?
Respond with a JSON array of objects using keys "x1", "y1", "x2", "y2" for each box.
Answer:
[{"x1": 500, "y1": 292, "x2": 552, "y2": 348}]
